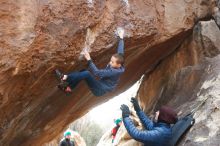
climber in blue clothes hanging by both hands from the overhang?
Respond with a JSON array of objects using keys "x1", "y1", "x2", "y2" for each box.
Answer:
[{"x1": 56, "y1": 29, "x2": 125, "y2": 96}]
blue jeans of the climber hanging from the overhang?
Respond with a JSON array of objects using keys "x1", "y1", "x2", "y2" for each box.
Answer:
[{"x1": 67, "y1": 70, "x2": 106, "y2": 96}]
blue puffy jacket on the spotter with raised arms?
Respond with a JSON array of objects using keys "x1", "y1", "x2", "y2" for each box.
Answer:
[{"x1": 123, "y1": 111, "x2": 172, "y2": 146}]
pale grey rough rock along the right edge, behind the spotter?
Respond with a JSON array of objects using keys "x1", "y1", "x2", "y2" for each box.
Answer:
[{"x1": 180, "y1": 21, "x2": 220, "y2": 146}]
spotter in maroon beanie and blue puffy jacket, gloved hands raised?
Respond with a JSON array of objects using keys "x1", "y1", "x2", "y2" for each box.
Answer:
[{"x1": 121, "y1": 98, "x2": 178, "y2": 146}]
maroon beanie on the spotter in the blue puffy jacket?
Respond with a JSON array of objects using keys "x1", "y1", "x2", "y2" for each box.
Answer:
[{"x1": 158, "y1": 106, "x2": 178, "y2": 124}]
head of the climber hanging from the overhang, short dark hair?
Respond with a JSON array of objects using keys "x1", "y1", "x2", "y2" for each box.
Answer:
[{"x1": 109, "y1": 54, "x2": 124, "y2": 68}]
